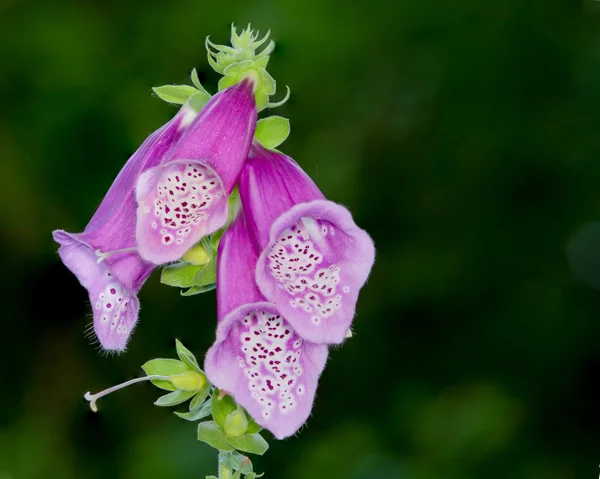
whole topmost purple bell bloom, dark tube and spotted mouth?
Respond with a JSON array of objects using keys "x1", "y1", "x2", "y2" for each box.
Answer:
[{"x1": 136, "y1": 79, "x2": 256, "y2": 264}]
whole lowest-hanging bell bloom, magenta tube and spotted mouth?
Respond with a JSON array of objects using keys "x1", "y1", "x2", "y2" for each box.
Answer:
[{"x1": 204, "y1": 214, "x2": 328, "y2": 439}]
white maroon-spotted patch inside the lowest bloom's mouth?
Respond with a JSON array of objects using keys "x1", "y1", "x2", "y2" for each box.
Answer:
[{"x1": 237, "y1": 311, "x2": 306, "y2": 419}]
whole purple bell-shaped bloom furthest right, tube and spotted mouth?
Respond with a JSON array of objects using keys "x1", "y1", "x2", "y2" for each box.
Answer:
[{"x1": 239, "y1": 143, "x2": 375, "y2": 344}]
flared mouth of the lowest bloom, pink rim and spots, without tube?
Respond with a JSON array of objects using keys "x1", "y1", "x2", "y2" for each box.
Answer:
[{"x1": 204, "y1": 302, "x2": 327, "y2": 439}]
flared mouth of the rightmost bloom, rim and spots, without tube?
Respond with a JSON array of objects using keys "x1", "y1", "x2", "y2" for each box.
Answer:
[{"x1": 256, "y1": 200, "x2": 375, "y2": 344}]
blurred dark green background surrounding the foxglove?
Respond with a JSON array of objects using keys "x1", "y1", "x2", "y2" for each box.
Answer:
[{"x1": 0, "y1": 0, "x2": 600, "y2": 479}]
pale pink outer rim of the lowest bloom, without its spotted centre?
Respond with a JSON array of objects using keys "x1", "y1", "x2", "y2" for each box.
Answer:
[{"x1": 204, "y1": 301, "x2": 328, "y2": 439}]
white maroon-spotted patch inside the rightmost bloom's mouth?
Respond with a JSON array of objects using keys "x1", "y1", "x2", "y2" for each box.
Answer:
[{"x1": 267, "y1": 218, "x2": 350, "y2": 325}]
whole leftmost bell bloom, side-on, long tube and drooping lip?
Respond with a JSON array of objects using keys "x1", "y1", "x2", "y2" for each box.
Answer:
[{"x1": 53, "y1": 105, "x2": 196, "y2": 351}]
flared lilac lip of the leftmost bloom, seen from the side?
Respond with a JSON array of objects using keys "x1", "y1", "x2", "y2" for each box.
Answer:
[{"x1": 53, "y1": 230, "x2": 146, "y2": 351}]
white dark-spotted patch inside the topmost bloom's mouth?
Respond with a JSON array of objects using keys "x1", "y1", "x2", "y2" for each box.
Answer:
[{"x1": 145, "y1": 163, "x2": 223, "y2": 245}]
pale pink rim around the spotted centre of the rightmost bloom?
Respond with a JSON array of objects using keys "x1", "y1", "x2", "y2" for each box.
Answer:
[{"x1": 255, "y1": 200, "x2": 375, "y2": 344}]
